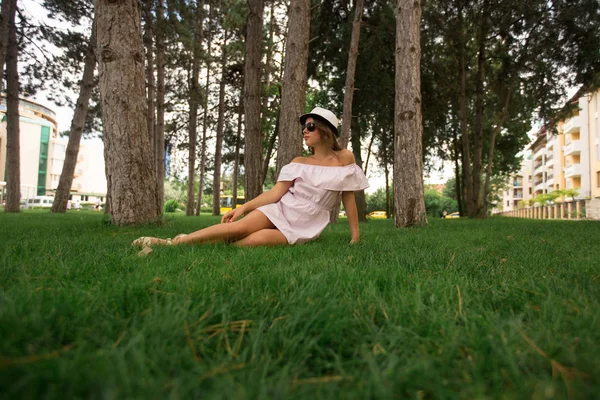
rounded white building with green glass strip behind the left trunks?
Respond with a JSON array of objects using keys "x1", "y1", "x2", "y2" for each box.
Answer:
[{"x1": 0, "y1": 96, "x2": 106, "y2": 205}]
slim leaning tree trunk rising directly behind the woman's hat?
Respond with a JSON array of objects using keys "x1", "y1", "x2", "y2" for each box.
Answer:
[{"x1": 340, "y1": 0, "x2": 365, "y2": 149}]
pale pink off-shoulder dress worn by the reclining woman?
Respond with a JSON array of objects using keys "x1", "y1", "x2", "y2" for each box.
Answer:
[{"x1": 257, "y1": 162, "x2": 369, "y2": 244}]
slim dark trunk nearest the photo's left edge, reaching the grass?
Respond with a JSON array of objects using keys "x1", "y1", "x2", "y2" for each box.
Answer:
[{"x1": 0, "y1": 0, "x2": 21, "y2": 212}]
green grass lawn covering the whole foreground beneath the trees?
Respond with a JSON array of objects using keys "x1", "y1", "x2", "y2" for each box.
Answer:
[{"x1": 0, "y1": 211, "x2": 600, "y2": 399}]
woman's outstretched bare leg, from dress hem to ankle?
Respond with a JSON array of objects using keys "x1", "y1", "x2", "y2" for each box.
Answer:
[{"x1": 172, "y1": 210, "x2": 279, "y2": 245}]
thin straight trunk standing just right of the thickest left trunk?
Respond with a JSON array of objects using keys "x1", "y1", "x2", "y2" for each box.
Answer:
[{"x1": 153, "y1": 0, "x2": 165, "y2": 210}]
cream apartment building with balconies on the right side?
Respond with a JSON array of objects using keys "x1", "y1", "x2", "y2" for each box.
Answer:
[{"x1": 502, "y1": 85, "x2": 600, "y2": 211}]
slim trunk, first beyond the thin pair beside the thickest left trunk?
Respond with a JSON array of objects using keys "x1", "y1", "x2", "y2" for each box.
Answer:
[{"x1": 185, "y1": 0, "x2": 204, "y2": 217}]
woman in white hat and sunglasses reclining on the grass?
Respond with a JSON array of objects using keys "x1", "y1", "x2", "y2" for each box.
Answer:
[{"x1": 133, "y1": 107, "x2": 368, "y2": 246}]
